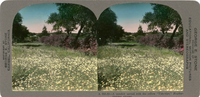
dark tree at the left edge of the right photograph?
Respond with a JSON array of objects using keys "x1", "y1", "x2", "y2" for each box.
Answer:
[{"x1": 96, "y1": 8, "x2": 124, "y2": 46}]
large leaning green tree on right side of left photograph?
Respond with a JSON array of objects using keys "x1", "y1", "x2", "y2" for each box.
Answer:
[{"x1": 47, "y1": 3, "x2": 96, "y2": 49}]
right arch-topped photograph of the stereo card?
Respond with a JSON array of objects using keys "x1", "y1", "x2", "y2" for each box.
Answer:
[{"x1": 96, "y1": 3, "x2": 184, "y2": 91}]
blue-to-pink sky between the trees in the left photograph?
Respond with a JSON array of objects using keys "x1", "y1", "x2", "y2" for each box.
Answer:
[{"x1": 19, "y1": 3, "x2": 58, "y2": 33}]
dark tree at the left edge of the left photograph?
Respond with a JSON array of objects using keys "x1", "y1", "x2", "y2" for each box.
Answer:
[{"x1": 12, "y1": 13, "x2": 29, "y2": 42}]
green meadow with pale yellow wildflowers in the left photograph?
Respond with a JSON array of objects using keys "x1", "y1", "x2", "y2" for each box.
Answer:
[{"x1": 12, "y1": 43, "x2": 98, "y2": 91}]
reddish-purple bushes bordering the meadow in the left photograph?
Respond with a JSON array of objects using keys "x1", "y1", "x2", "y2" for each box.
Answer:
[{"x1": 39, "y1": 35, "x2": 97, "y2": 55}]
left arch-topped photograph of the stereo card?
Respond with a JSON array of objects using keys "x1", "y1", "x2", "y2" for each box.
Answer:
[{"x1": 12, "y1": 3, "x2": 98, "y2": 91}]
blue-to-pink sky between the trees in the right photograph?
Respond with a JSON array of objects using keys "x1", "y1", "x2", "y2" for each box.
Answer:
[{"x1": 110, "y1": 3, "x2": 153, "y2": 32}]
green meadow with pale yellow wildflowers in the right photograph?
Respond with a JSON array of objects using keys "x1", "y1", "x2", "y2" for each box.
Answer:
[{"x1": 97, "y1": 46, "x2": 184, "y2": 91}]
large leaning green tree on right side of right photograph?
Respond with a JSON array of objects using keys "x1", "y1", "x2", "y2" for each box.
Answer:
[{"x1": 141, "y1": 4, "x2": 182, "y2": 41}]
